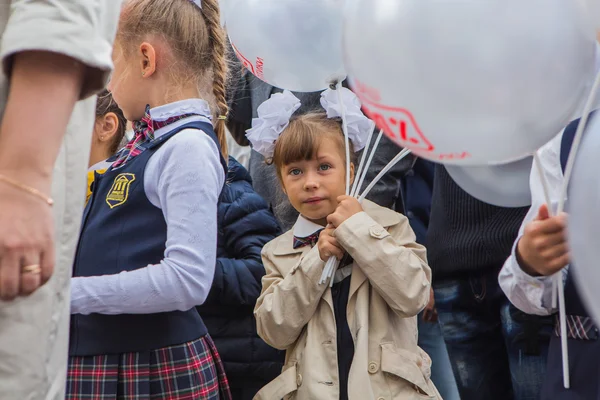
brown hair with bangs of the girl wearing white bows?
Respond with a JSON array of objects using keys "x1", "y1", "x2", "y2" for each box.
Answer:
[{"x1": 270, "y1": 112, "x2": 356, "y2": 181}]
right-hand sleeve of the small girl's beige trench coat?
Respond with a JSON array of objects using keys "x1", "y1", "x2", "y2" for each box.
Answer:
[{"x1": 335, "y1": 212, "x2": 431, "y2": 317}]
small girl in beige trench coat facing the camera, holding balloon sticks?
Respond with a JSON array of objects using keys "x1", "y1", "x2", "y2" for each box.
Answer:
[{"x1": 248, "y1": 89, "x2": 439, "y2": 400}]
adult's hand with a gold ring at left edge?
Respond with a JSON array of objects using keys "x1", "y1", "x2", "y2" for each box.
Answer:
[{"x1": 0, "y1": 170, "x2": 54, "y2": 300}]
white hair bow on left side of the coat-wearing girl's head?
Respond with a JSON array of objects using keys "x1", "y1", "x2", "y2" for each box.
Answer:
[{"x1": 246, "y1": 90, "x2": 301, "y2": 159}]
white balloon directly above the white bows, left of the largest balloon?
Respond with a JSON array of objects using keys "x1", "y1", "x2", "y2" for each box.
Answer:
[{"x1": 227, "y1": 0, "x2": 346, "y2": 92}]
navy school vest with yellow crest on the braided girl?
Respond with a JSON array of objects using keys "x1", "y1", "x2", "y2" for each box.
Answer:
[{"x1": 69, "y1": 122, "x2": 227, "y2": 356}]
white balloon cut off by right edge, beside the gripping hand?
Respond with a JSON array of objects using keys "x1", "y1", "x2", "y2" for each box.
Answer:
[{"x1": 567, "y1": 115, "x2": 600, "y2": 321}]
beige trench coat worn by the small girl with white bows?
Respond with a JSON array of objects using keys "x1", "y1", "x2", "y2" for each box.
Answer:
[{"x1": 254, "y1": 201, "x2": 440, "y2": 400}]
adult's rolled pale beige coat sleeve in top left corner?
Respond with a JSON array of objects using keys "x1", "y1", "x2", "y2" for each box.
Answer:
[{"x1": 0, "y1": 0, "x2": 121, "y2": 98}]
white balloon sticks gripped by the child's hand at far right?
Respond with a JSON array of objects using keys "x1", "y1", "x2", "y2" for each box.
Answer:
[{"x1": 534, "y1": 67, "x2": 600, "y2": 389}]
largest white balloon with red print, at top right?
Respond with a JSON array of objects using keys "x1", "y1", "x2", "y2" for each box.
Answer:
[{"x1": 344, "y1": 0, "x2": 596, "y2": 165}]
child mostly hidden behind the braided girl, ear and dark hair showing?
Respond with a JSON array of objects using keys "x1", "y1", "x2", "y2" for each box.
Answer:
[{"x1": 86, "y1": 90, "x2": 127, "y2": 200}]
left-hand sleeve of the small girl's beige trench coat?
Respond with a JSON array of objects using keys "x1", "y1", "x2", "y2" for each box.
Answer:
[{"x1": 254, "y1": 245, "x2": 329, "y2": 350}]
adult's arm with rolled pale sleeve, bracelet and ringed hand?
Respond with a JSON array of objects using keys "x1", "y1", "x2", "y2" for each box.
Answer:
[{"x1": 0, "y1": 0, "x2": 119, "y2": 299}]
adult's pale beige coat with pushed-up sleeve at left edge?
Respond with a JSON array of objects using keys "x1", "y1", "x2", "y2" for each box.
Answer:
[{"x1": 0, "y1": 0, "x2": 120, "y2": 400}]
